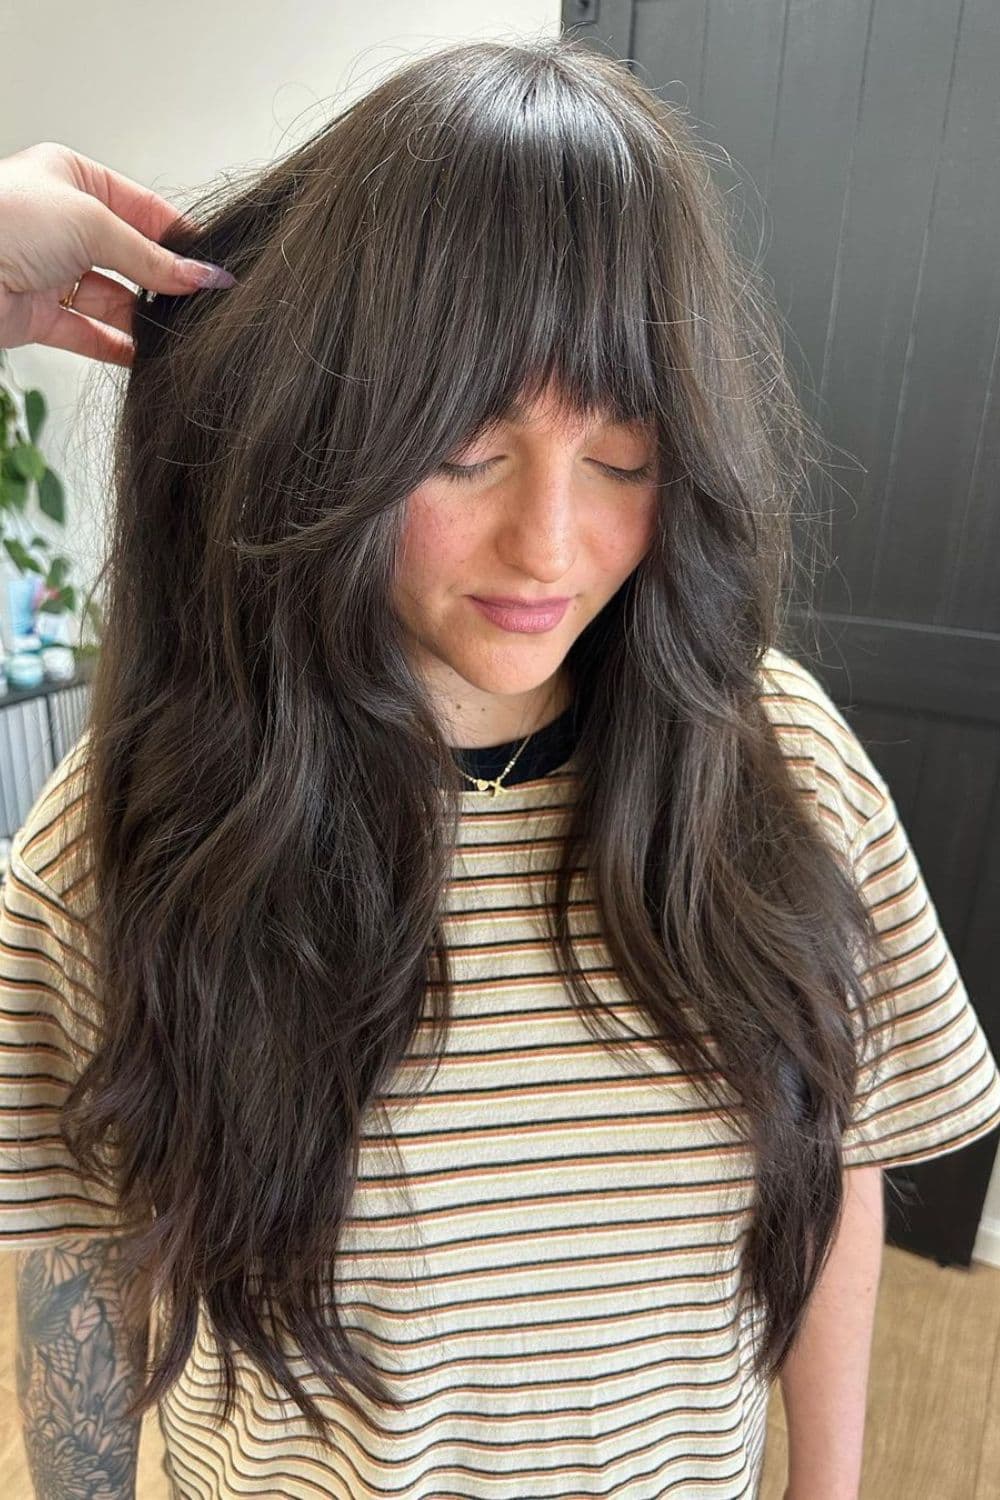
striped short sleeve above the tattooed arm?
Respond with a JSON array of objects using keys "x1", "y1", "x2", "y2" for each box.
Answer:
[{"x1": 0, "y1": 831, "x2": 117, "y2": 1250}]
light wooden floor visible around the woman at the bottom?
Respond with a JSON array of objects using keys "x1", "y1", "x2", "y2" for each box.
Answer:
[{"x1": 0, "y1": 1245, "x2": 1000, "y2": 1500}]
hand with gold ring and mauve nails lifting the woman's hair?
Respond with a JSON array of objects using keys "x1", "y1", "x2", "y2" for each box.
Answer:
[{"x1": 0, "y1": 141, "x2": 235, "y2": 365}]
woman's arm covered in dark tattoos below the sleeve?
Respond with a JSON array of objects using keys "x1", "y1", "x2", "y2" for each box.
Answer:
[{"x1": 15, "y1": 1238, "x2": 150, "y2": 1500}]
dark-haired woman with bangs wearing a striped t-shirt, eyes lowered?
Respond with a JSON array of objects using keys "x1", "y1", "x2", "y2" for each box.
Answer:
[{"x1": 0, "y1": 39, "x2": 1000, "y2": 1500}]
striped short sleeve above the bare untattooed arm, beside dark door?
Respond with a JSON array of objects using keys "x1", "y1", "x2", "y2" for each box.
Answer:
[{"x1": 843, "y1": 762, "x2": 1000, "y2": 1167}]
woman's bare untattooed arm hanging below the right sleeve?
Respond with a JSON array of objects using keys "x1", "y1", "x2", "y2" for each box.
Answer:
[{"x1": 780, "y1": 1167, "x2": 885, "y2": 1500}]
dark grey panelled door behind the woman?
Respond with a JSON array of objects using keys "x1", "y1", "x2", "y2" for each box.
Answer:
[{"x1": 562, "y1": 0, "x2": 1000, "y2": 1265}]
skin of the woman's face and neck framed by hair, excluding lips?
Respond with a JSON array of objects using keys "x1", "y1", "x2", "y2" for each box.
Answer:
[{"x1": 394, "y1": 381, "x2": 657, "y2": 746}]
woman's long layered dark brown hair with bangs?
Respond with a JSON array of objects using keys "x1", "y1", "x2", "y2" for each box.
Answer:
[{"x1": 63, "y1": 36, "x2": 880, "y2": 1436}]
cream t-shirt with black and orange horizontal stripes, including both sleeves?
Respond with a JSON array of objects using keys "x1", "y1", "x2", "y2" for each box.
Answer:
[{"x1": 0, "y1": 651, "x2": 1000, "y2": 1500}]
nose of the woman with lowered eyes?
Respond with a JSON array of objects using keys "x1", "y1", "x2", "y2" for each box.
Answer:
[{"x1": 496, "y1": 462, "x2": 580, "y2": 584}]
